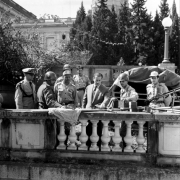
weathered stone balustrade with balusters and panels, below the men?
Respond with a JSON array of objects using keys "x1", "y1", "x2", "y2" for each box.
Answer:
[{"x1": 0, "y1": 110, "x2": 180, "y2": 164}]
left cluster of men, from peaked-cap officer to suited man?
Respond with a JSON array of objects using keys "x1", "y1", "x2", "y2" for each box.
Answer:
[{"x1": 15, "y1": 64, "x2": 109, "y2": 109}]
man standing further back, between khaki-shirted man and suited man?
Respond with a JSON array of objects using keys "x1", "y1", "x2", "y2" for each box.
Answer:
[{"x1": 73, "y1": 66, "x2": 91, "y2": 107}]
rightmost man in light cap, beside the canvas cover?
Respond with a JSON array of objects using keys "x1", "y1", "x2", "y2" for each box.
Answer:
[{"x1": 146, "y1": 71, "x2": 172, "y2": 107}]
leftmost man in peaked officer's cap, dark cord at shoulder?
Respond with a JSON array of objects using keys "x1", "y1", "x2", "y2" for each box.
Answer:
[{"x1": 15, "y1": 68, "x2": 37, "y2": 109}]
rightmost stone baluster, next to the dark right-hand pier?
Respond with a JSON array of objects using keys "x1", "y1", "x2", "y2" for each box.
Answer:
[{"x1": 136, "y1": 121, "x2": 145, "y2": 153}]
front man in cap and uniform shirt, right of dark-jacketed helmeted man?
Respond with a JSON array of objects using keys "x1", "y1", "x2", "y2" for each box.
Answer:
[{"x1": 54, "y1": 70, "x2": 77, "y2": 108}]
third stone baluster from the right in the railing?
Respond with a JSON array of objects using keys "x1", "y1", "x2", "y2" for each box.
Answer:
[{"x1": 112, "y1": 121, "x2": 122, "y2": 152}]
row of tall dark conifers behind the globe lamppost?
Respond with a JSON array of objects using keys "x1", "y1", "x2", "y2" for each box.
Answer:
[{"x1": 71, "y1": 0, "x2": 179, "y2": 65}]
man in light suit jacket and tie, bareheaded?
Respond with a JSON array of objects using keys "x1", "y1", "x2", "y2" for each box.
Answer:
[{"x1": 82, "y1": 73, "x2": 109, "y2": 109}]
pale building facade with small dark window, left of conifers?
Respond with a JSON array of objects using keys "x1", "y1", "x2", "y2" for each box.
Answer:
[{"x1": 14, "y1": 18, "x2": 75, "y2": 51}]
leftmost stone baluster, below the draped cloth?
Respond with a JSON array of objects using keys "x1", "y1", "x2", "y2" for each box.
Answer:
[{"x1": 57, "y1": 121, "x2": 66, "y2": 149}]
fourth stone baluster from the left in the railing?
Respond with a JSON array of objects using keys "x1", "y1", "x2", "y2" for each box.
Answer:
[{"x1": 89, "y1": 120, "x2": 99, "y2": 151}]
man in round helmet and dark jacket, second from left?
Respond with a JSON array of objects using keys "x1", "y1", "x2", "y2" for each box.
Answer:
[{"x1": 37, "y1": 71, "x2": 62, "y2": 109}]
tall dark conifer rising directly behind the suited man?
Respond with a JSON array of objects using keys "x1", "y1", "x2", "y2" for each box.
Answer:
[{"x1": 90, "y1": 0, "x2": 119, "y2": 65}]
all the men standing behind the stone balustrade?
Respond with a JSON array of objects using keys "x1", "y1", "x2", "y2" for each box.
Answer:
[{"x1": 15, "y1": 64, "x2": 171, "y2": 109}]
